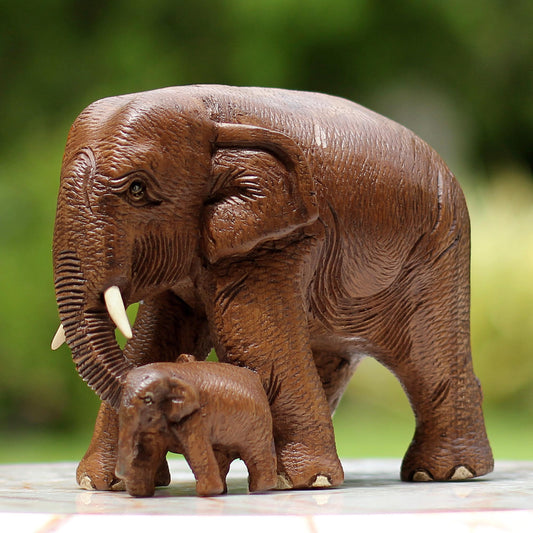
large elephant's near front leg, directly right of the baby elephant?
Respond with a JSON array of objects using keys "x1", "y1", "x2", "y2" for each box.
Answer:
[{"x1": 206, "y1": 261, "x2": 344, "y2": 489}]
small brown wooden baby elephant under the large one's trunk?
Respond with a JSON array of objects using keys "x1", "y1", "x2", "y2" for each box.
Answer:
[{"x1": 116, "y1": 356, "x2": 277, "y2": 496}]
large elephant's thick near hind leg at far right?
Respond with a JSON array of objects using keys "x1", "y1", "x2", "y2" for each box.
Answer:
[{"x1": 382, "y1": 231, "x2": 493, "y2": 481}]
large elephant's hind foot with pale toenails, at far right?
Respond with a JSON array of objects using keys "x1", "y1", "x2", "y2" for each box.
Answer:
[{"x1": 401, "y1": 428, "x2": 494, "y2": 481}]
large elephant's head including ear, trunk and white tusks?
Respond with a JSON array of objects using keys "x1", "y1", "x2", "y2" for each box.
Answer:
[{"x1": 53, "y1": 88, "x2": 318, "y2": 408}]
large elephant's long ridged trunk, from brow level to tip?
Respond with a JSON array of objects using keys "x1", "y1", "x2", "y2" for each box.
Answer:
[{"x1": 53, "y1": 148, "x2": 133, "y2": 409}]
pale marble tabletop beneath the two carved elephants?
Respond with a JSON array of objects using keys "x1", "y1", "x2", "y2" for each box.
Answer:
[{"x1": 0, "y1": 459, "x2": 533, "y2": 533}]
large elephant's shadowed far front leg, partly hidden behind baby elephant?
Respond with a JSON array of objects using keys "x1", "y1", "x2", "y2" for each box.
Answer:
[{"x1": 76, "y1": 291, "x2": 211, "y2": 490}]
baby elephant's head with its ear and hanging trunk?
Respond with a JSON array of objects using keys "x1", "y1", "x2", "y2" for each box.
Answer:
[{"x1": 116, "y1": 365, "x2": 200, "y2": 496}]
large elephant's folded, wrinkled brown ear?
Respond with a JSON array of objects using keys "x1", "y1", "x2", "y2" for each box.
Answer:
[{"x1": 203, "y1": 120, "x2": 318, "y2": 263}]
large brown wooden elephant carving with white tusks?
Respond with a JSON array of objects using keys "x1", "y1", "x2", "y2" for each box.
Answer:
[{"x1": 53, "y1": 86, "x2": 493, "y2": 489}]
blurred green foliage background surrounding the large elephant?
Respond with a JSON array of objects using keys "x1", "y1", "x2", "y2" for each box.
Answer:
[{"x1": 0, "y1": 0, "x2": 533, "y2": 455}]
